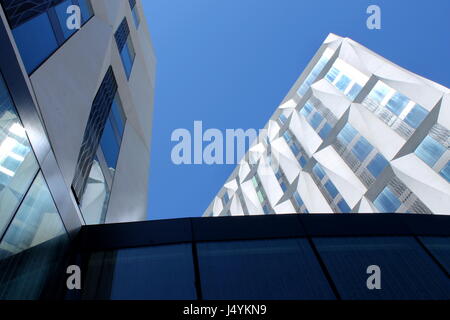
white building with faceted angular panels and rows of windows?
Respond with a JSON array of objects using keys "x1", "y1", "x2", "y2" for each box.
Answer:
[{"x1": 204, "y1": 34, "x2": 450, "y2": 216}]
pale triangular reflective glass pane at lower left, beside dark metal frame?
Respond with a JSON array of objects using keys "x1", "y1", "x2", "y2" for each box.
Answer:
[{"x1": 0, "y1": 173, "x2": 66, "y2": 258}]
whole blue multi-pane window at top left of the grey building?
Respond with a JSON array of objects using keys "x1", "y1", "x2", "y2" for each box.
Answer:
[{"x1": 12, "y1": 0, "x2": 93, "y2": 74}]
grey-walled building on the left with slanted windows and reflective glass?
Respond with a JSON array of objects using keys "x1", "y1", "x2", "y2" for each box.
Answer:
[{"x1": 0, "y1": 0, "x2": 156, "y2": 298}]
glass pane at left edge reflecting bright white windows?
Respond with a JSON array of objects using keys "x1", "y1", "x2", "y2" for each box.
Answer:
[{"x1": 0, "y1": 75, "x2": 39, "y2": 237}]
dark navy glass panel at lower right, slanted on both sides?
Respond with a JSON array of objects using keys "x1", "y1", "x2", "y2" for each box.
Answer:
[{"x1": 313, "y1": 237, "x2": 450, "y2": 300}]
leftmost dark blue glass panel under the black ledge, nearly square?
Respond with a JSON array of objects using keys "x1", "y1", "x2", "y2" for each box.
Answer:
[{"x1": 110, "y1": 244, "x2": 196, "y2": 300}]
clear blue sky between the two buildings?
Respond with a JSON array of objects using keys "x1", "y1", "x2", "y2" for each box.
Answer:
[{"x1": 142, "y1": 0, "x2": 450, "y2": 219}]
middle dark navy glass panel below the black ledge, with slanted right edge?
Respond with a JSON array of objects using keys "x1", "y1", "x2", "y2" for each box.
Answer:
[{"x1": 198, "y1": 239, "x2": 335, "y2": 300}]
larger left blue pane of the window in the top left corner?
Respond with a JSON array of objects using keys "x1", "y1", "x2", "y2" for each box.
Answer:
[{"x1": 12, "y1": 12, "x2": 58, "y2": 73}]
